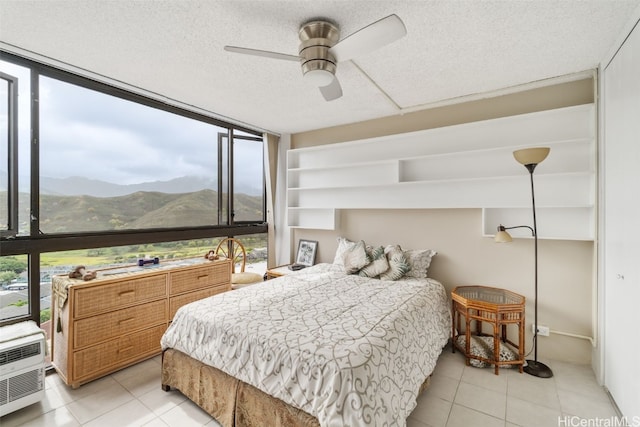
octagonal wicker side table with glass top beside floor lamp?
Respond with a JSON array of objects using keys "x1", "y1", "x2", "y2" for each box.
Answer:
[{"x1": 451, "y1": 286, "x2": 525, "y2": 375}]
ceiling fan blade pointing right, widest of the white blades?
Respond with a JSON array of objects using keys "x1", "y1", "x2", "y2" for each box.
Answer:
[{"x1": 330, "y1": 14, "x2": 407, "y2": 61}]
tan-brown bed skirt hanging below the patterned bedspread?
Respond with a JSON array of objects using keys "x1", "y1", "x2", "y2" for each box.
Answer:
[{"x1": 162, "y1": 349, "x2": 429, "y2": 427}]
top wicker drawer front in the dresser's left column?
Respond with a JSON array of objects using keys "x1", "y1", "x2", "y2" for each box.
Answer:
[{"x1": 73, "y1": 274, "x2": 167, "y2": 317}]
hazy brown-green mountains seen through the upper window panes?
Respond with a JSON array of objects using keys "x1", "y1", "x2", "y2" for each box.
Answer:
[{"x1": 0, "y1": 177, "x2": 263, "y2": 233}]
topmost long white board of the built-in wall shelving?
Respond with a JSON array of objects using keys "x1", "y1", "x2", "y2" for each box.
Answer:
[{"x1": 287, "y1": 104, "x2": 595, "y2": 169}]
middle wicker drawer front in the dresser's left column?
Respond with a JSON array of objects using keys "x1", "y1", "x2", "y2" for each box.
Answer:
[{"x1": 73, "y1": 299, "x2": 167, "y2": 348}]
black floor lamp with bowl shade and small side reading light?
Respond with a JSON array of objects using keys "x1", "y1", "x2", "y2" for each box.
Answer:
[{"x1": 495, "y1": 147, "x2": 553, "y2": 378}]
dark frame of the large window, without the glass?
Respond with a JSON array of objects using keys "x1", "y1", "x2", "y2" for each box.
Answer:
[{"x1": 0, "y1": 49, "x2": 268, "y2": 325}]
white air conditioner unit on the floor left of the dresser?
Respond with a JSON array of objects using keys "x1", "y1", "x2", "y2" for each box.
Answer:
[{"x1": 0, "y1": 321, "x2": 45, "y2": 416}]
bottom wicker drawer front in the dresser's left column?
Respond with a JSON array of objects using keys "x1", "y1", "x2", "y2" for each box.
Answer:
[{"x1": 73, "y1": 325, "x2": 167, "y2": 381}]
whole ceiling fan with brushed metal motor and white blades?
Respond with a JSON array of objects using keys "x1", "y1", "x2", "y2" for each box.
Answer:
[{"x1": 224, "y1": 14, "x2": 407, "y2": 101}]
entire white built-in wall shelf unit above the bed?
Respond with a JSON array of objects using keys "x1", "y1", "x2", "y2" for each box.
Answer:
[{"x1": 287, "y1": 104, "x2": 596, "y2": 240}]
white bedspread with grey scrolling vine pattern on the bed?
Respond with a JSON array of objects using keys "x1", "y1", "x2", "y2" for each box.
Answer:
[{"x1": 162, "y1": 264, "x2": 451, "y2": 427}]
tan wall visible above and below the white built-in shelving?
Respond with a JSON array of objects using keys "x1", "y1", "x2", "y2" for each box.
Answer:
[{"x1": 291, "y1": 79, "x2": 594, "y2": 363}]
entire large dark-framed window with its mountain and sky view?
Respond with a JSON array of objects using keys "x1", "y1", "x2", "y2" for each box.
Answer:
[{"x1": 0, "y1": 54, "x2": 267, "y2": 362}]
